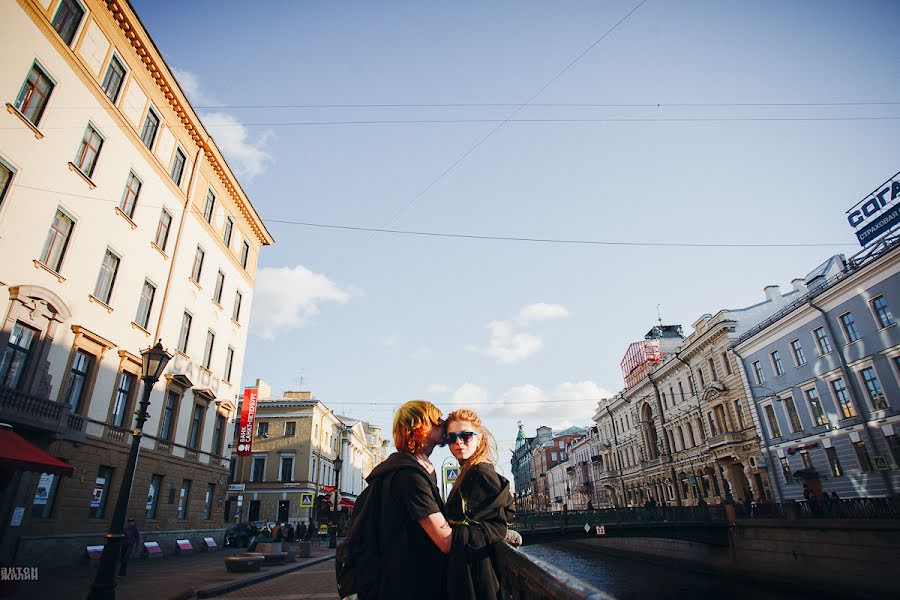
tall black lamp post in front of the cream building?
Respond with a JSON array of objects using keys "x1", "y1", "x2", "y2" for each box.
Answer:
[{"x1": 88, "y1": 340, "x2": 172, "y2": 600}]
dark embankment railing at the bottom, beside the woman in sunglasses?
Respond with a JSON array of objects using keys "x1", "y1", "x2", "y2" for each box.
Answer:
[{"x1": 494, "y1": 544, "x2": 613, "y2": 600}]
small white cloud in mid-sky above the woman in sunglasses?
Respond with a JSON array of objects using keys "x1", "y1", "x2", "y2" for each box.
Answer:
[{"x1": 465, "y1": 302, "x2": 569, "y2": 364}]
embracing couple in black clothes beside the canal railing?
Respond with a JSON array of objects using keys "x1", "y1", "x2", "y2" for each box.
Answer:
[{"x1": 351, "y1": 400, "x2": 521, "y2": 600}]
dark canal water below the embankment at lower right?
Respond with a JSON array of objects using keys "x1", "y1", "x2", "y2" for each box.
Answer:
[{"x1": 521, "y1": 542, "x2": 840, "y2": 600}]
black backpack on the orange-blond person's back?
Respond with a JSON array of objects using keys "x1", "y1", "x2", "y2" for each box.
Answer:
[{"x1": 334, "y1": 472, "x2": 393, "y2": 598}]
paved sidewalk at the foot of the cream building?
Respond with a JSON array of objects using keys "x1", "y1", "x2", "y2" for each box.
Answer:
[{"x1": 12, "y1": 544, "x2": 337, "y2": 600}]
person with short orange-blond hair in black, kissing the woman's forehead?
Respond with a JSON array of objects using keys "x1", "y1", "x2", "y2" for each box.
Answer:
[{"x1": 358, "y1": 400, "x2": 451, "y2": 600}]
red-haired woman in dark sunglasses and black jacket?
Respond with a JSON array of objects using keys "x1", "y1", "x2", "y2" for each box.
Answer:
[{"x1": 444, "y1": 409, "x2": 521, "y2": 600}]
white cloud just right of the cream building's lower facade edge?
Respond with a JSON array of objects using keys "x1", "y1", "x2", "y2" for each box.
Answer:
[{"x1": 251, "y1": 265, "x2": 351, "y2": 339}]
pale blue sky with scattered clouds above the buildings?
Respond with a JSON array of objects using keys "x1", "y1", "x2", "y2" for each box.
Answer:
[{"x1": 131, "y1": 0, "x2": 900, "y2": 475}]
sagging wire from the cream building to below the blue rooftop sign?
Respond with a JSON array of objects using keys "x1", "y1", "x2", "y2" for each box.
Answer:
[{"x1": 11, "y1": 183, "x2": 855, "y2": 248}]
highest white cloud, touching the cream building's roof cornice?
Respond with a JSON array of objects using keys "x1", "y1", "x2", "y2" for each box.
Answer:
[{"x1": 172, "y1": 68, "x2": 275, "y2": 180}]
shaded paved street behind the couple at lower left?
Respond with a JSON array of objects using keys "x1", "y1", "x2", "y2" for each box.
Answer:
[{"x1": 13, "y1": 548, "x2": 337, "y2": 600}]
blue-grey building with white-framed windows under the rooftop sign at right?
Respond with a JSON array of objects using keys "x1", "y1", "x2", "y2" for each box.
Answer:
[{"x1": 733, "y1": 235, "x2": 900, "y2": 500}]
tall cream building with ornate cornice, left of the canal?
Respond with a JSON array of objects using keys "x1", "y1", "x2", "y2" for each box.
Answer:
[{"x1": 0, "y1": 0, "x2": 273, "y2": 565}]
